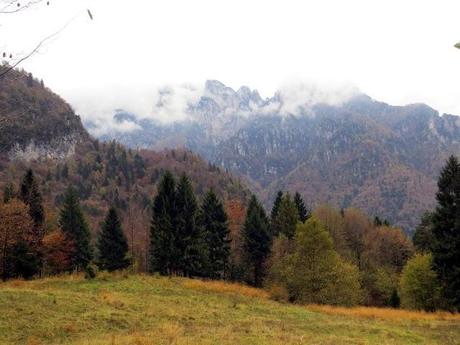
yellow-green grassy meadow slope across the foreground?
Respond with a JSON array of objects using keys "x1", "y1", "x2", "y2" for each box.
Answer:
[{"x1": 0, "y1": 275, "x2": 460, "y2": 345}]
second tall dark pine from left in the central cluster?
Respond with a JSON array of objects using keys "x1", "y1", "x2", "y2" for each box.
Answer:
[{"x1": 174, "y1": 174, "x2": 207, "y2": 277}]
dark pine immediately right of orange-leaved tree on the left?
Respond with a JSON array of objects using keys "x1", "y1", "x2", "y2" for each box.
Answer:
[{"x1": 59, "y1": 187, "x2": 93, "y2": 270}]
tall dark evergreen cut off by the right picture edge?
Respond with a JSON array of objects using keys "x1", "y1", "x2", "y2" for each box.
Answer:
[{"x1": 431, "y1": 156, "x2": 460, "y2": 310}]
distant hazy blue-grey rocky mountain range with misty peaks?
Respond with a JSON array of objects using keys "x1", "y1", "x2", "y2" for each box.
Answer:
[{"x1": 91, "y1": 81, "x2": 460, "y2": 232}]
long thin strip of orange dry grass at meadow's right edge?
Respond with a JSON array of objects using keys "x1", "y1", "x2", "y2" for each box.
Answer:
[{"x1": 307, "y1": 305, "x2": 460, "y2": 321}]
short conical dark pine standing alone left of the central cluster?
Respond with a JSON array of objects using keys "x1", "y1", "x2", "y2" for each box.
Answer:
[{"x1": 97, "y1": 207, "x2": 130, "y2": 272}]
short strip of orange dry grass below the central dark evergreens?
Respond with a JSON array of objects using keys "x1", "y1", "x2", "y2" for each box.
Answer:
[{"x1": 182, "y1": 279, "x2": 270, "y2": 298}]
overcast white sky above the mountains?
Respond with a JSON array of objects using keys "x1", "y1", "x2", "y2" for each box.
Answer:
[{"x1": 0, "y1": 0, "x2": 460, "y2": 125}]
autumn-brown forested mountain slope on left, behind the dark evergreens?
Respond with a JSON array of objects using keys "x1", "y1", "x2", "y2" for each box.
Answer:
[{"x1": 0, "y1": 67, "x2": 249, "y2": 269}]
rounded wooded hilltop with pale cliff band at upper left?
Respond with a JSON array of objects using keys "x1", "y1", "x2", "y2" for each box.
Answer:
[{"x1": 0, "y1": 65, "x2": 89, "y2": 159}]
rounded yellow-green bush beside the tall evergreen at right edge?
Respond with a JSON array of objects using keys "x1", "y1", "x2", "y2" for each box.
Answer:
[{"x1": 400, "y1": 254, "x2": 440, "y2": 311}]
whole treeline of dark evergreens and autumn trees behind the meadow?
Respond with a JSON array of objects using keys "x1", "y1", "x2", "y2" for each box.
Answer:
[{"x1": 0, "y1": 157, "x2": 460, "y2": 311}]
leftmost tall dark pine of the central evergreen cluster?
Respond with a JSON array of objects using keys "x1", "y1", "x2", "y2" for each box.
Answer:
[{"x1": 150, "y1": 171, "x2": 177, "y2": 274}]
